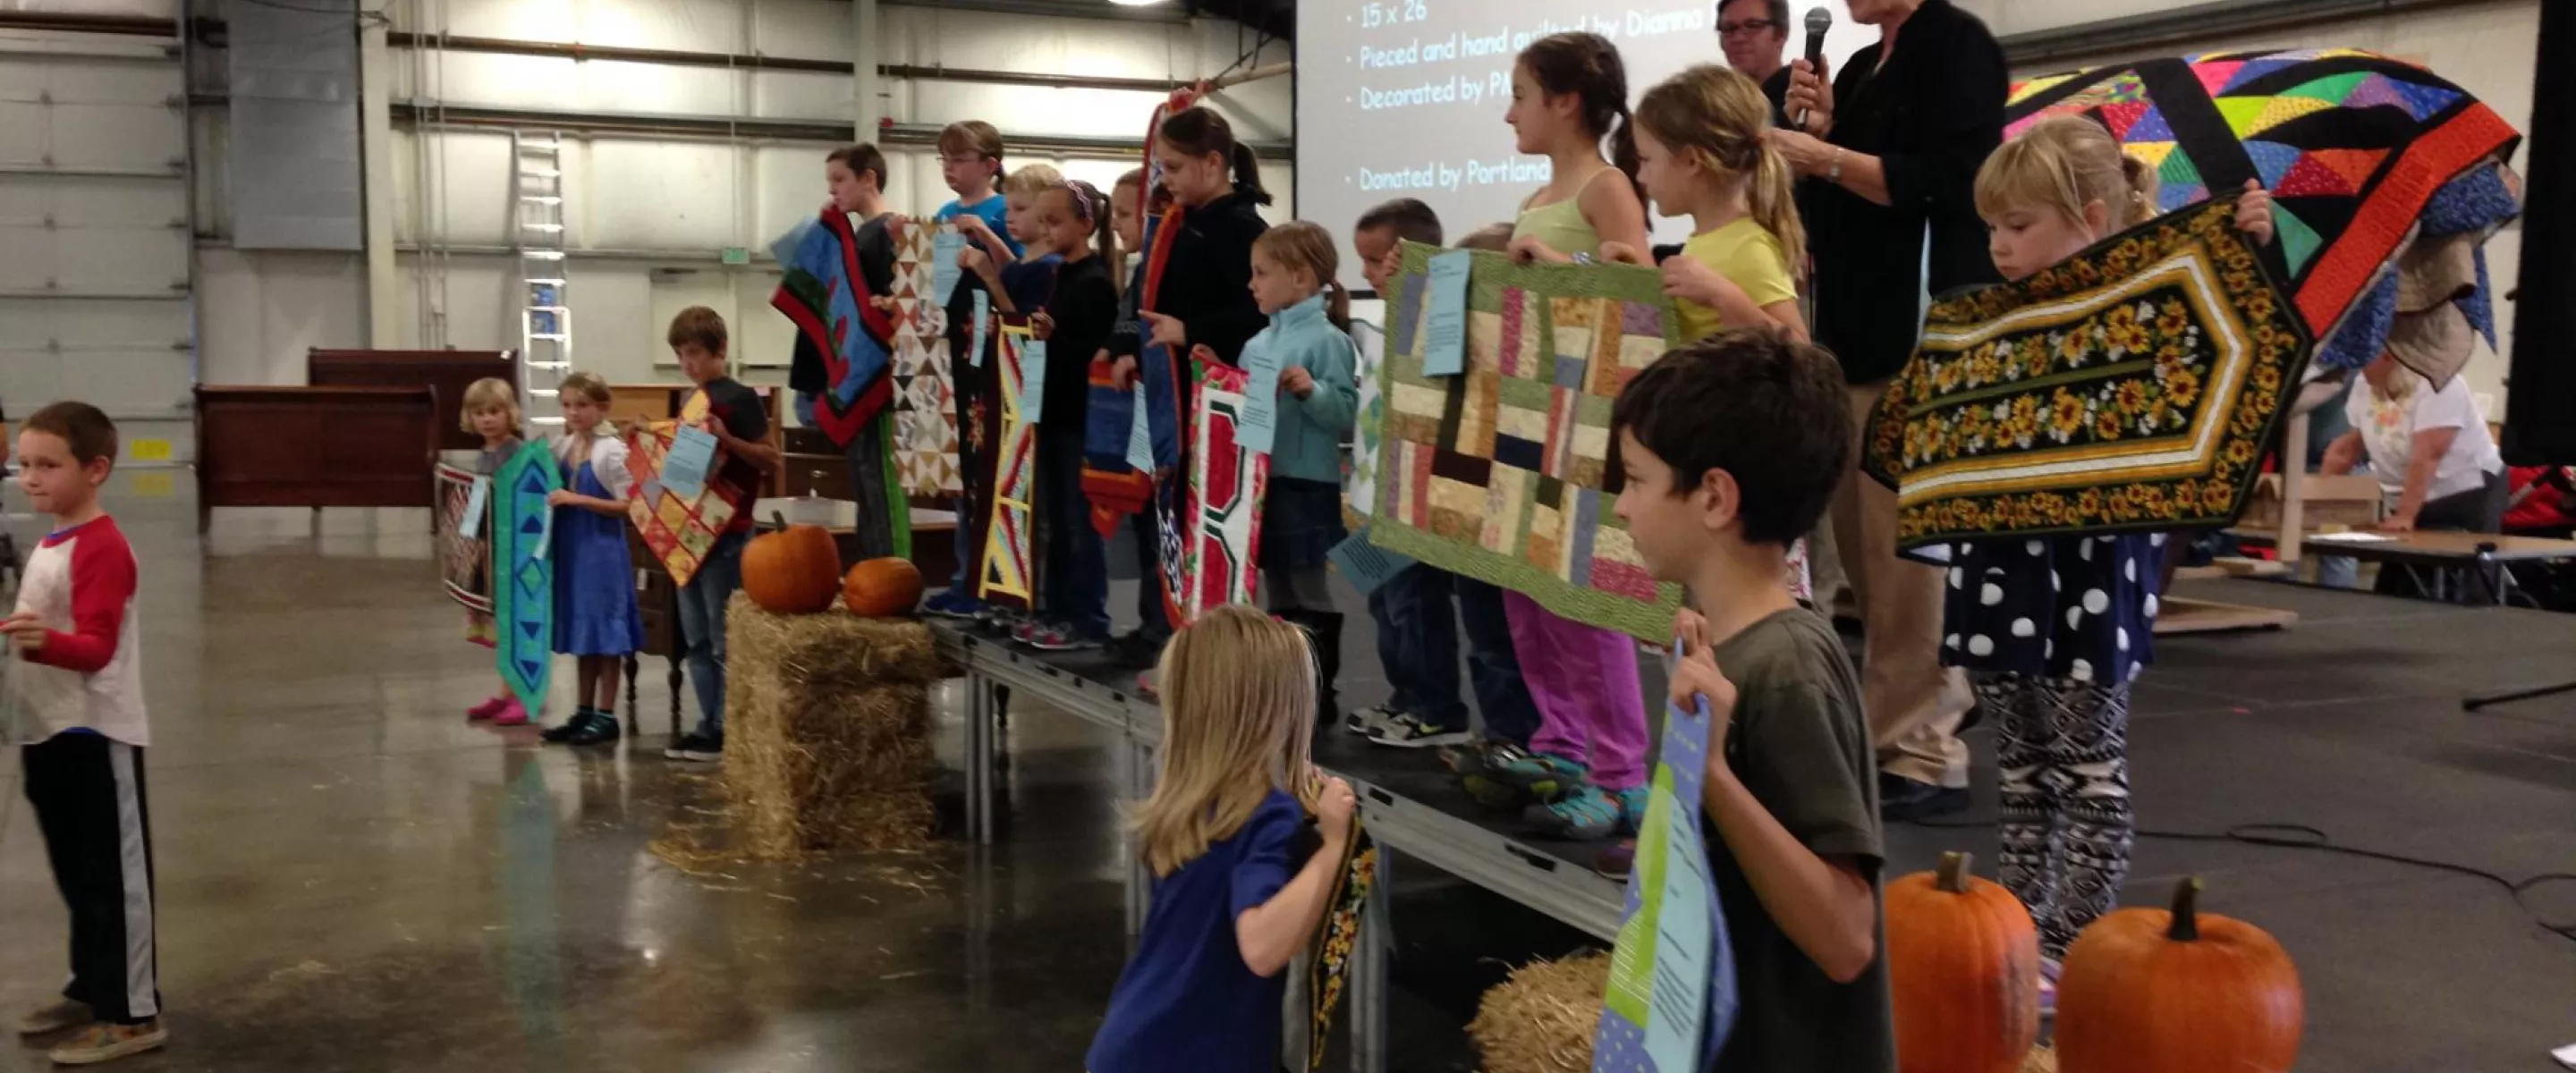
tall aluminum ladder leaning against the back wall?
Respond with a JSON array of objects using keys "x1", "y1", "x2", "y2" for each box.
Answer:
[{"x1": 510, "y1": 131, "x2": 572, "y2": 437}]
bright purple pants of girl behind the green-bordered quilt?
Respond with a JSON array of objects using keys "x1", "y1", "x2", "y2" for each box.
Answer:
[{"x1": 1502, "y1": 592, "x2": 1646, "y2": 790}]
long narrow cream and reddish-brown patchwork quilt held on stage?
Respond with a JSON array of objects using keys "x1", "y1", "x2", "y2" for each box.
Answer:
[{"x1": 894, "y1": 221, "x2": 963, "y2": 496}]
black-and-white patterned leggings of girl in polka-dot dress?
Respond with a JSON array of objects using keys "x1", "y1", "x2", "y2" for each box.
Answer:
[{"x1": 1973, "y1": 672, "x2": 2131, "y2": 959}]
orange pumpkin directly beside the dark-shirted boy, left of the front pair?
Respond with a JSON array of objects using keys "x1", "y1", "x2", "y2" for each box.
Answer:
[{"x1": 1885, "y1": 854, "x2": 2040, "y2": 1073}]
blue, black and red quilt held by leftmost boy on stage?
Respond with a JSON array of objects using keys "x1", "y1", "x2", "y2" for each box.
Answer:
[{"x1": 770, "y1": 208, "x2": 894, "y2": 448}]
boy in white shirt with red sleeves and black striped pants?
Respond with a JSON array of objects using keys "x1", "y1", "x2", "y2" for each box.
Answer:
[{"x1": 0, "y1": 401, "x2": 167, "y2": 1065}]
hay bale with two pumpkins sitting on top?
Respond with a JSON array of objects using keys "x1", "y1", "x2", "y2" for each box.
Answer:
[{"x1": 724, "y1": 595, "x2": 940, "y2": 859}]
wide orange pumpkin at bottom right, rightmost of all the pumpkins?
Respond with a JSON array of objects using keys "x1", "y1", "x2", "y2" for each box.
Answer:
[{"x1": 2055, "y1": 877, "x2": 2306, "y2": 1073}]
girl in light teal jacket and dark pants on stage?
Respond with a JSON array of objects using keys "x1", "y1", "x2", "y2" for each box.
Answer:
[{"x1": 1244, "y1": 221, "x2": 1360, "y2": 721}]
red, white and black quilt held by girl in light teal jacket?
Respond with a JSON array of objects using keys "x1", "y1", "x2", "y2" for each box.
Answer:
[{"x1": 1165, "y1": 363, "x2": 1270, "y2": 622}]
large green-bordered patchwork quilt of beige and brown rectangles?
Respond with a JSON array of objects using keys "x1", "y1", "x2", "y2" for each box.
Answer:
[{"x1": 1368, "y1": 242, "x2": 1682, "y2": 641}]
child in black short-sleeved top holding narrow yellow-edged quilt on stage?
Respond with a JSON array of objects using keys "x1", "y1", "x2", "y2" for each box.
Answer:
[{"x1": 1028, "y1": 180, "x2": 1118, "y2": 651}]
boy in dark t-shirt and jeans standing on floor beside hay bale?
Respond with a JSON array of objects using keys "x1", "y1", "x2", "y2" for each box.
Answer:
[{"x1": 662, "y1": 306, "x2": 785, "y2": 765}]
